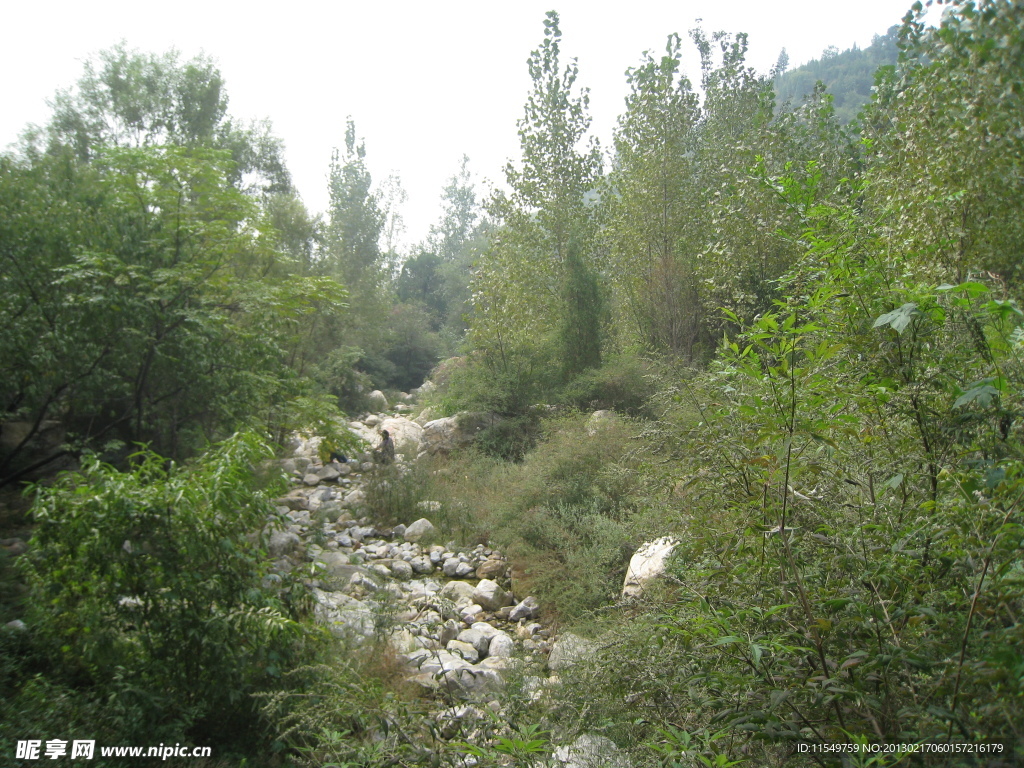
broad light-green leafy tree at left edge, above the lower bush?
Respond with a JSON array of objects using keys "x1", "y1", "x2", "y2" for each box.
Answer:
[{"x1": 0, "y1": 58, "x2": 345, "y2": 482}]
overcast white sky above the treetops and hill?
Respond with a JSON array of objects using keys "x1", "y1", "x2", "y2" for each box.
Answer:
[{"x1": 0, "y1": 0, "x2": 929, "y2": 249}]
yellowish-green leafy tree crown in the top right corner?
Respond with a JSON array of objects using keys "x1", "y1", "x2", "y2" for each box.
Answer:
[{"x1": 867, "y1": 0, "x2": 1024, "y2": 287}]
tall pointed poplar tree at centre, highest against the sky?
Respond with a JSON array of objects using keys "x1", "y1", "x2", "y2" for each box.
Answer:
[{"x1": 471, "y1": 11, "x2": 602, "y2": 391}]
